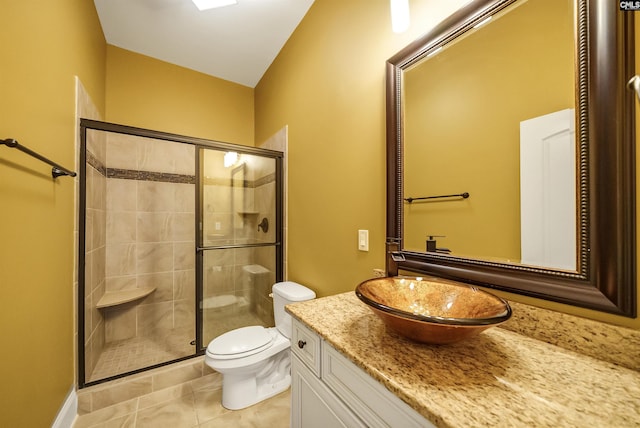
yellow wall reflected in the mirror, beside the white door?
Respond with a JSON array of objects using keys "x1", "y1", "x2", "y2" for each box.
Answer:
[{"x1": 403, "y1": 0, "x2": 576, "y2": 262}]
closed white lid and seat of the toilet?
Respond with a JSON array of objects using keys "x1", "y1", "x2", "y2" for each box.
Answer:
[{"x1": 207, "y1": 325, "x2": 275, "y2": 360}]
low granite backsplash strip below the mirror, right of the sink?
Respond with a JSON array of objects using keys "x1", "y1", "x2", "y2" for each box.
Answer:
[{"x1": 499, "y1": 302, "x2": 640, "y2": 371}]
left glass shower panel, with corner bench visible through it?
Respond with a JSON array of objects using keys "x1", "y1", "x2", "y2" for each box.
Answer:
[{"x1": 78, "y1": 120, "x2": 197, "y2": 387}]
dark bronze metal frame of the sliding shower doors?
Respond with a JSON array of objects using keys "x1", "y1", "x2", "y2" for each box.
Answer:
[{"x1": 76, "y1": 119, "x2": 284, "y2": 389}]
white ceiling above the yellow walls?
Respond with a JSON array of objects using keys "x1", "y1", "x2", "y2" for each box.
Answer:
[{"x1": 94, "y1": 0, "x2": 314, "y2": 88}]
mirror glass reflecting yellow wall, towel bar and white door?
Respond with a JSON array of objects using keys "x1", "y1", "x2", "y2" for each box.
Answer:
[{"x1": 403, "y1": 0, "x2": 577, "y2": 270}]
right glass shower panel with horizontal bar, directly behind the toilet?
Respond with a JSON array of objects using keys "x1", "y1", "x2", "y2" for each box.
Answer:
[{"x1": 197, "y1": 147, "x2": 283, "y2": 349}]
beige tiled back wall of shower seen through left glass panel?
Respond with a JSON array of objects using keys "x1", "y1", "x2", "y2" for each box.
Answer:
[{"x1": 103, "y1": 133, "x2": 195, "y2": 342}]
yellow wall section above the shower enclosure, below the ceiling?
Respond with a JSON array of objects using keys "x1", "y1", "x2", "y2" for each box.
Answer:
[{"x1": 106, "y1": 45, "x2": 254, "y2": 146}]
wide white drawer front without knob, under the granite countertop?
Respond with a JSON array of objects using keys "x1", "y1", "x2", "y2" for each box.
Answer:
[{"x1": 322, "y1": 346, "x2": 435, "y2": 428}]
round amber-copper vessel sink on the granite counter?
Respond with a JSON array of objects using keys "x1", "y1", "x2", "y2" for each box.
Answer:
[{"x1": 356, "y1": 277, "x2": 511, "y2": 344}]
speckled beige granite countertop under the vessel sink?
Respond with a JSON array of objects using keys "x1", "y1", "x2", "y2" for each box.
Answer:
[{"x1": 287, "y1": 292, "x2": 640, "y2": 427}]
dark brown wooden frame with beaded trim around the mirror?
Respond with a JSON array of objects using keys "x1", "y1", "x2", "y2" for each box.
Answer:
[{"x1": 386, "y1": 0, "x2": 637, "y2": 317}]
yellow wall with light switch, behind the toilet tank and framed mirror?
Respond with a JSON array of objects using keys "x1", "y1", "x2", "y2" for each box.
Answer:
[{"x1": 255, "y1": 0, "x2": 640, "y2": 329}]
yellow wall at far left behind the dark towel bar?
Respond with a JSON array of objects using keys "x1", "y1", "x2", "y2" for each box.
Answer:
[{"x1": 0, "y1": 0, "x2": 105, "y2": 428}]
